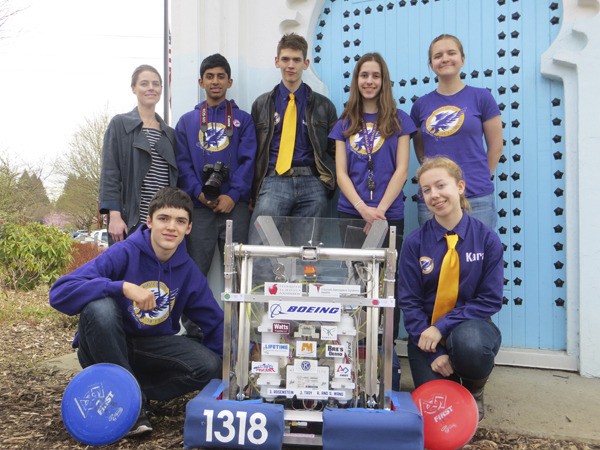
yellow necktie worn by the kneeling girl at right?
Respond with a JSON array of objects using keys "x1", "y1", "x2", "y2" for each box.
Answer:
[{"x1": 431, "y1": 234, "x2": 460, "y2": 325}]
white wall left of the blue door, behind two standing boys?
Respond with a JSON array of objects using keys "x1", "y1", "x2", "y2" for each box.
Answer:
[{"x1": 171, "y1": 0, "x2": 327, "y2": 119}]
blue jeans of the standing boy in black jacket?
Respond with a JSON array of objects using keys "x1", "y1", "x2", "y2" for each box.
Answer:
[{"x1": 248, "y1": 175, "x2": 327, "y2": 245}]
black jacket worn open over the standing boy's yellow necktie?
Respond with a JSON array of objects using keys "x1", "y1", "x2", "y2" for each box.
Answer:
[{"x1": 252, "y1": 85, "x2": 337, "y2": 200}]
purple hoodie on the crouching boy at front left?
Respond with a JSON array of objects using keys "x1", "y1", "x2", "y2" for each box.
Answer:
[{"x1": 50, "y1": 224, "x2": 223, "y2": 355}]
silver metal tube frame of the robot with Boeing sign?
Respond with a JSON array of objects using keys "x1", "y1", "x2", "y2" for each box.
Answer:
[{"x1": 223, "y1": 220, "x2": 397, "y2": 409}]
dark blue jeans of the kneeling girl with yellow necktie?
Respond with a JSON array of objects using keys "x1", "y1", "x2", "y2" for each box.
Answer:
[{"x1": 408, "y1": 320, "x2": 502, "y2": 388}]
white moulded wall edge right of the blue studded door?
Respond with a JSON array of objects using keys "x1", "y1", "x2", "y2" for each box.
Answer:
[{"x1": 541, "y1": 0, "x2": 600, "y2": 377}]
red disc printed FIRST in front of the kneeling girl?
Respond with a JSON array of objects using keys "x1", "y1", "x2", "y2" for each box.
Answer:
[{"x1": 412, "y1": 380, "x2": 479, "y2": 450}]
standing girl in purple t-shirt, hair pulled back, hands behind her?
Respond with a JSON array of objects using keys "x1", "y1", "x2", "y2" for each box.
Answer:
[{"x1": 410, "y1": 34, "x2": 503, "y2": 229}]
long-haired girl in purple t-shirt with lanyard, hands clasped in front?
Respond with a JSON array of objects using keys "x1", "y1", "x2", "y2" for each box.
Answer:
[{"x1": 329, "y1": 53, "x2": 416, "y2": 348}]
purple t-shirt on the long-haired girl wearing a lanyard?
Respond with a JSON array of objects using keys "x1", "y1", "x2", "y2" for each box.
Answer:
[{"x1": 329, "y1": 109, "x2": 417, "y2": 220}]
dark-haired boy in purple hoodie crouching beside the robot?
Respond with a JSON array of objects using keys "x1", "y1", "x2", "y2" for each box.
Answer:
[{"x1": 50, "y1": 187, "x2": 223, "y2": 435}]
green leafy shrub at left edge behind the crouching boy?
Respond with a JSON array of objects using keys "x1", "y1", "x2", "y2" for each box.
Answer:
[{"x1": 0, "y1": 222, "x2": 72, "y2": 291}]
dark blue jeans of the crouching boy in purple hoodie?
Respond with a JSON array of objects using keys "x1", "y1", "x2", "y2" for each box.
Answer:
[{"x1": 77, "y1": 297, "x2": 222, "y2": 400}]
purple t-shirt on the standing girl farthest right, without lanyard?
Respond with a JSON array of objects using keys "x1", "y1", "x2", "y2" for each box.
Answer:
[{"x1": 410, "y1": 86, "x2": 500, "y2": 197}]
